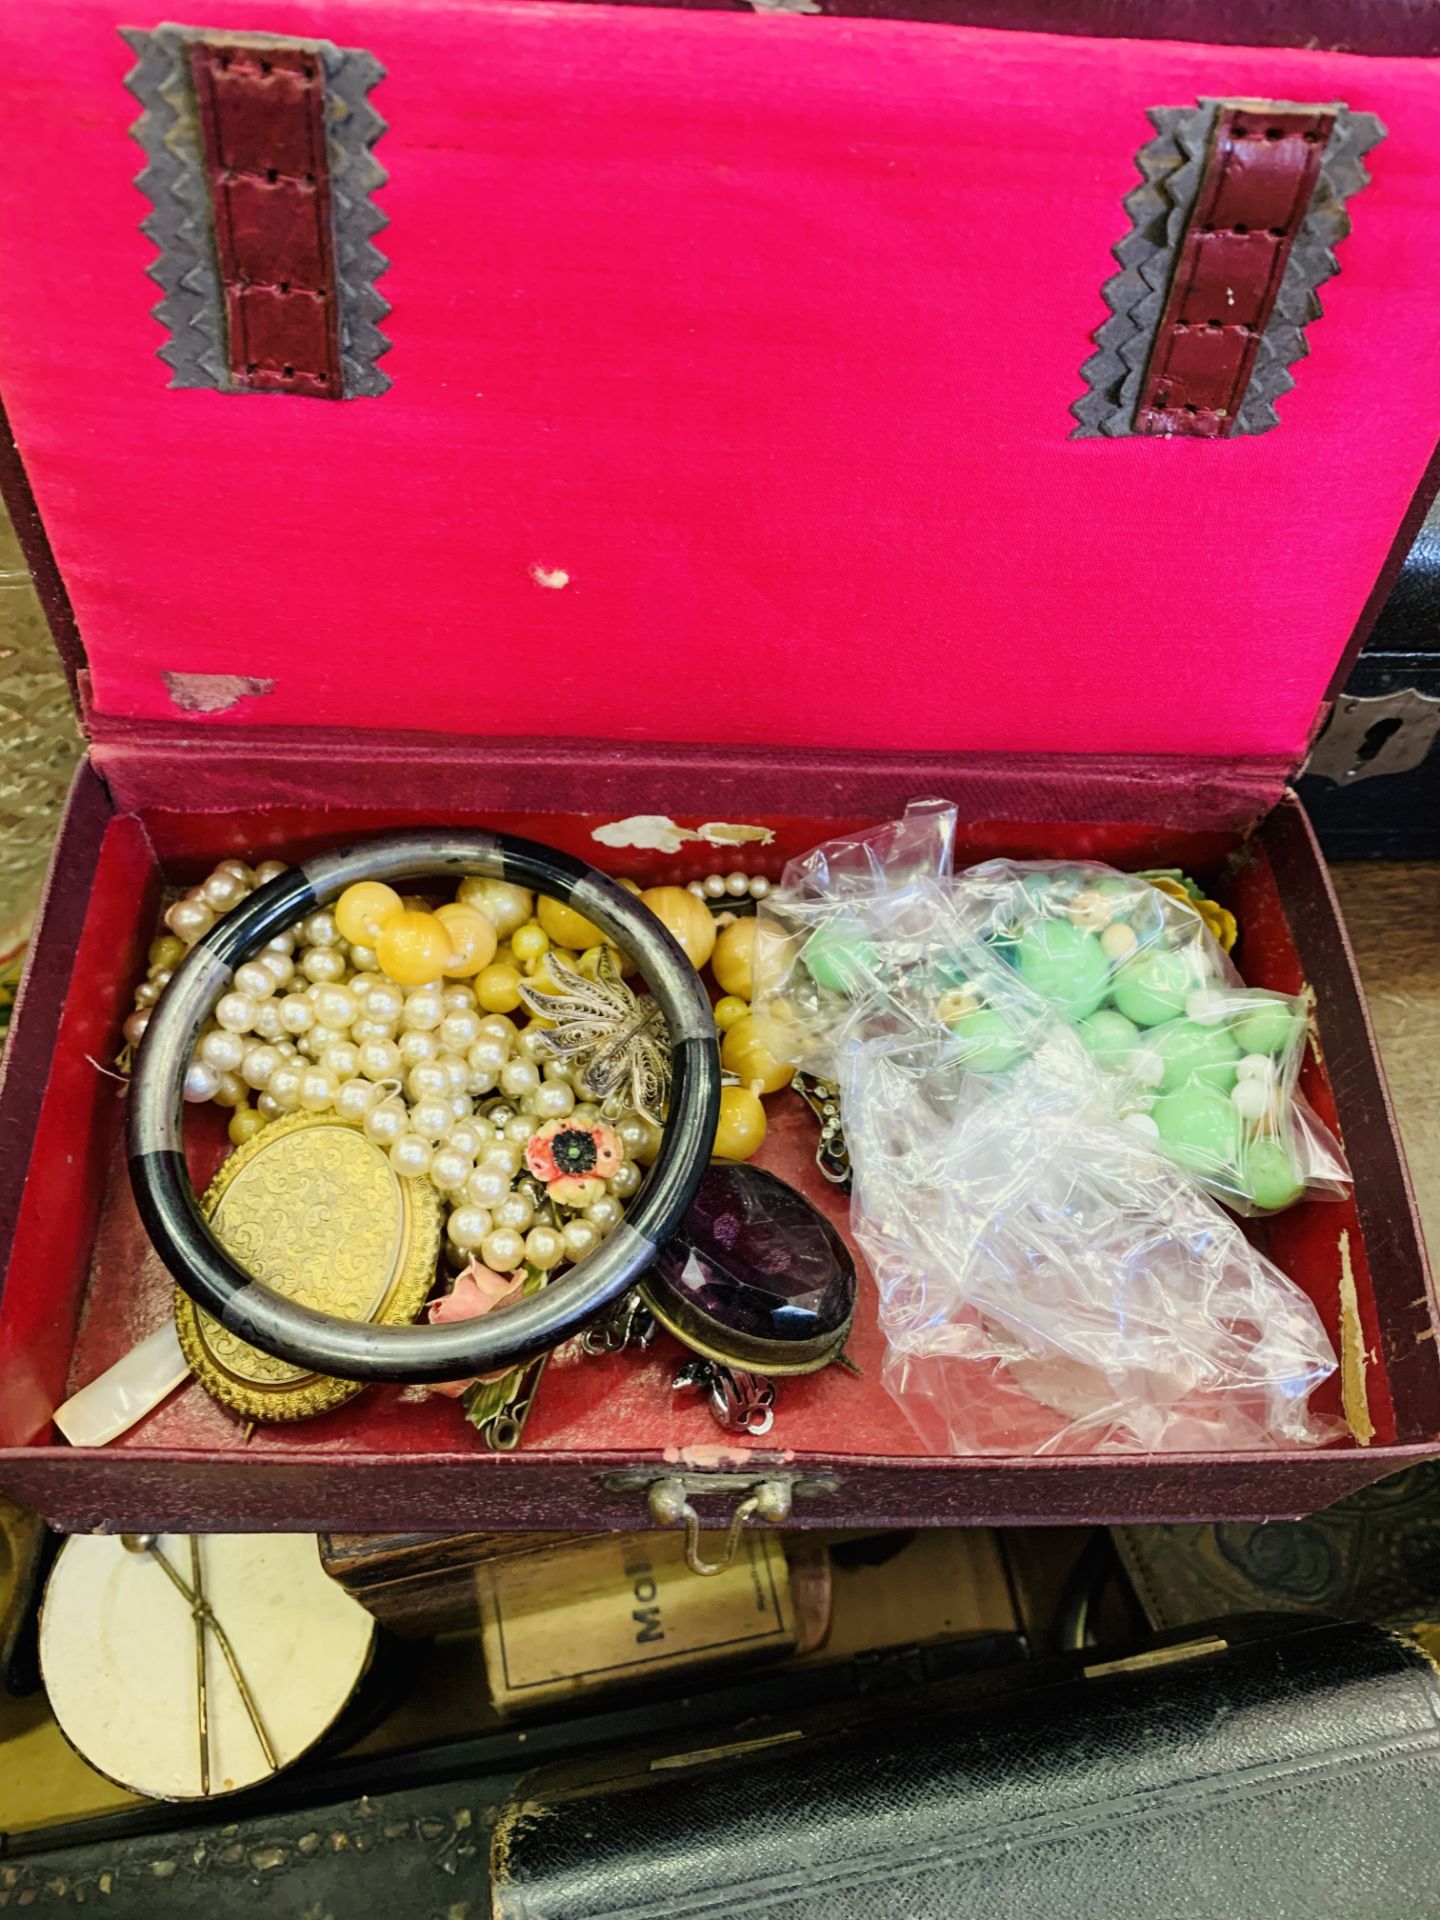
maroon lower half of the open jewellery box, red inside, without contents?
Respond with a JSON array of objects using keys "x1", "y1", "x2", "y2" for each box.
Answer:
[{"x1": 0, "y1": 741, "x2": 1440, "y2": 1526}]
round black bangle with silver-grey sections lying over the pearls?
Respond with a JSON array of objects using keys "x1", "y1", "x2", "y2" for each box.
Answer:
[{"x1": 129, "y1": 831, "x2": 720, "y2": 1382}]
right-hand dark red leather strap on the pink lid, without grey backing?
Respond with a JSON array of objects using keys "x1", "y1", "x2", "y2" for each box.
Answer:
[{"x1": 1135, "y1": 104, "x2": 1334, "y2": 440}]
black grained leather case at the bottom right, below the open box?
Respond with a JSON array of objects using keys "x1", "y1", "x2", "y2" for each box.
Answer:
[{"x1": 492, "y1": 1620, "x2": 1440, "y2": 1920}]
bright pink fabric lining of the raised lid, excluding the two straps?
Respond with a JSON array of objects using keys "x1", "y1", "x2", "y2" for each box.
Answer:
[{"x1": 0, "y1": 0, "x2": 1440, "y2": 764}]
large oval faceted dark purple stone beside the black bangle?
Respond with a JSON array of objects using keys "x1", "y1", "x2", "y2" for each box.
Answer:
[{"x1": 647, "y1": 1162, "x2": 854, "y2": 1365}]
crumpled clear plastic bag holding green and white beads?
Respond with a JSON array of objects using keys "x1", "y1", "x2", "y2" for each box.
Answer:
[{"x1": 755, "y1": 804, "x2": 1344, "y2": 1453}]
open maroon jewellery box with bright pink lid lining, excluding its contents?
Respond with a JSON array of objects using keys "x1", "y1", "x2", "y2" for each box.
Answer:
[{"x1": 0, "y1": 0, "x2": 1440, "y2": 1530}]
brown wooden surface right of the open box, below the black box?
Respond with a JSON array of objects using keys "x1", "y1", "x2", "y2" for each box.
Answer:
[{"x1": 1331, "y1": 860, "x2": 1440, "y2": 1265}]
